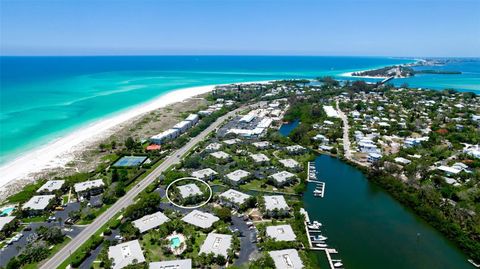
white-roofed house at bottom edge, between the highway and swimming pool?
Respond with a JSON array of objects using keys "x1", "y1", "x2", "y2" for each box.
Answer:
[{"x1": 108, "y1": 240, "x2": 145, "y2": 269}]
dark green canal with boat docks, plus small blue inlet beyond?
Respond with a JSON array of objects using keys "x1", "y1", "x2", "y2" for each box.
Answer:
[{"x1": 280, "y1": 122, "x2": 473, "y2": 269}]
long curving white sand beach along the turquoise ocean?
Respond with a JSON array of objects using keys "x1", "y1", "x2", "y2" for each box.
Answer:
[{"x1": 0, "y1": 81, "x2": 269, "y2": 195}]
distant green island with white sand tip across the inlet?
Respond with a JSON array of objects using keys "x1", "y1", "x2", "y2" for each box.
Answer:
[{"x1": 351, "y1": 60, "x2": 462, "y2": 78}]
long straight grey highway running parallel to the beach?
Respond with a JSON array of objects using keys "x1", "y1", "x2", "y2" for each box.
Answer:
[{"x1": 40, "y1": 107, "x2": 243, "y2": 269}]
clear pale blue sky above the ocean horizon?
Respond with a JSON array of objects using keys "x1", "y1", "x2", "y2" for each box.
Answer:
[{"x1": 0, "y1": 0, "x2": 480, "y2": 56}]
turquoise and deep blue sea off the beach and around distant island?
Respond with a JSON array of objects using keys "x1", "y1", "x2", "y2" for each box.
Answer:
[{"x1": 0, "y1": 56, "x2": 480, "y2": 164}]
